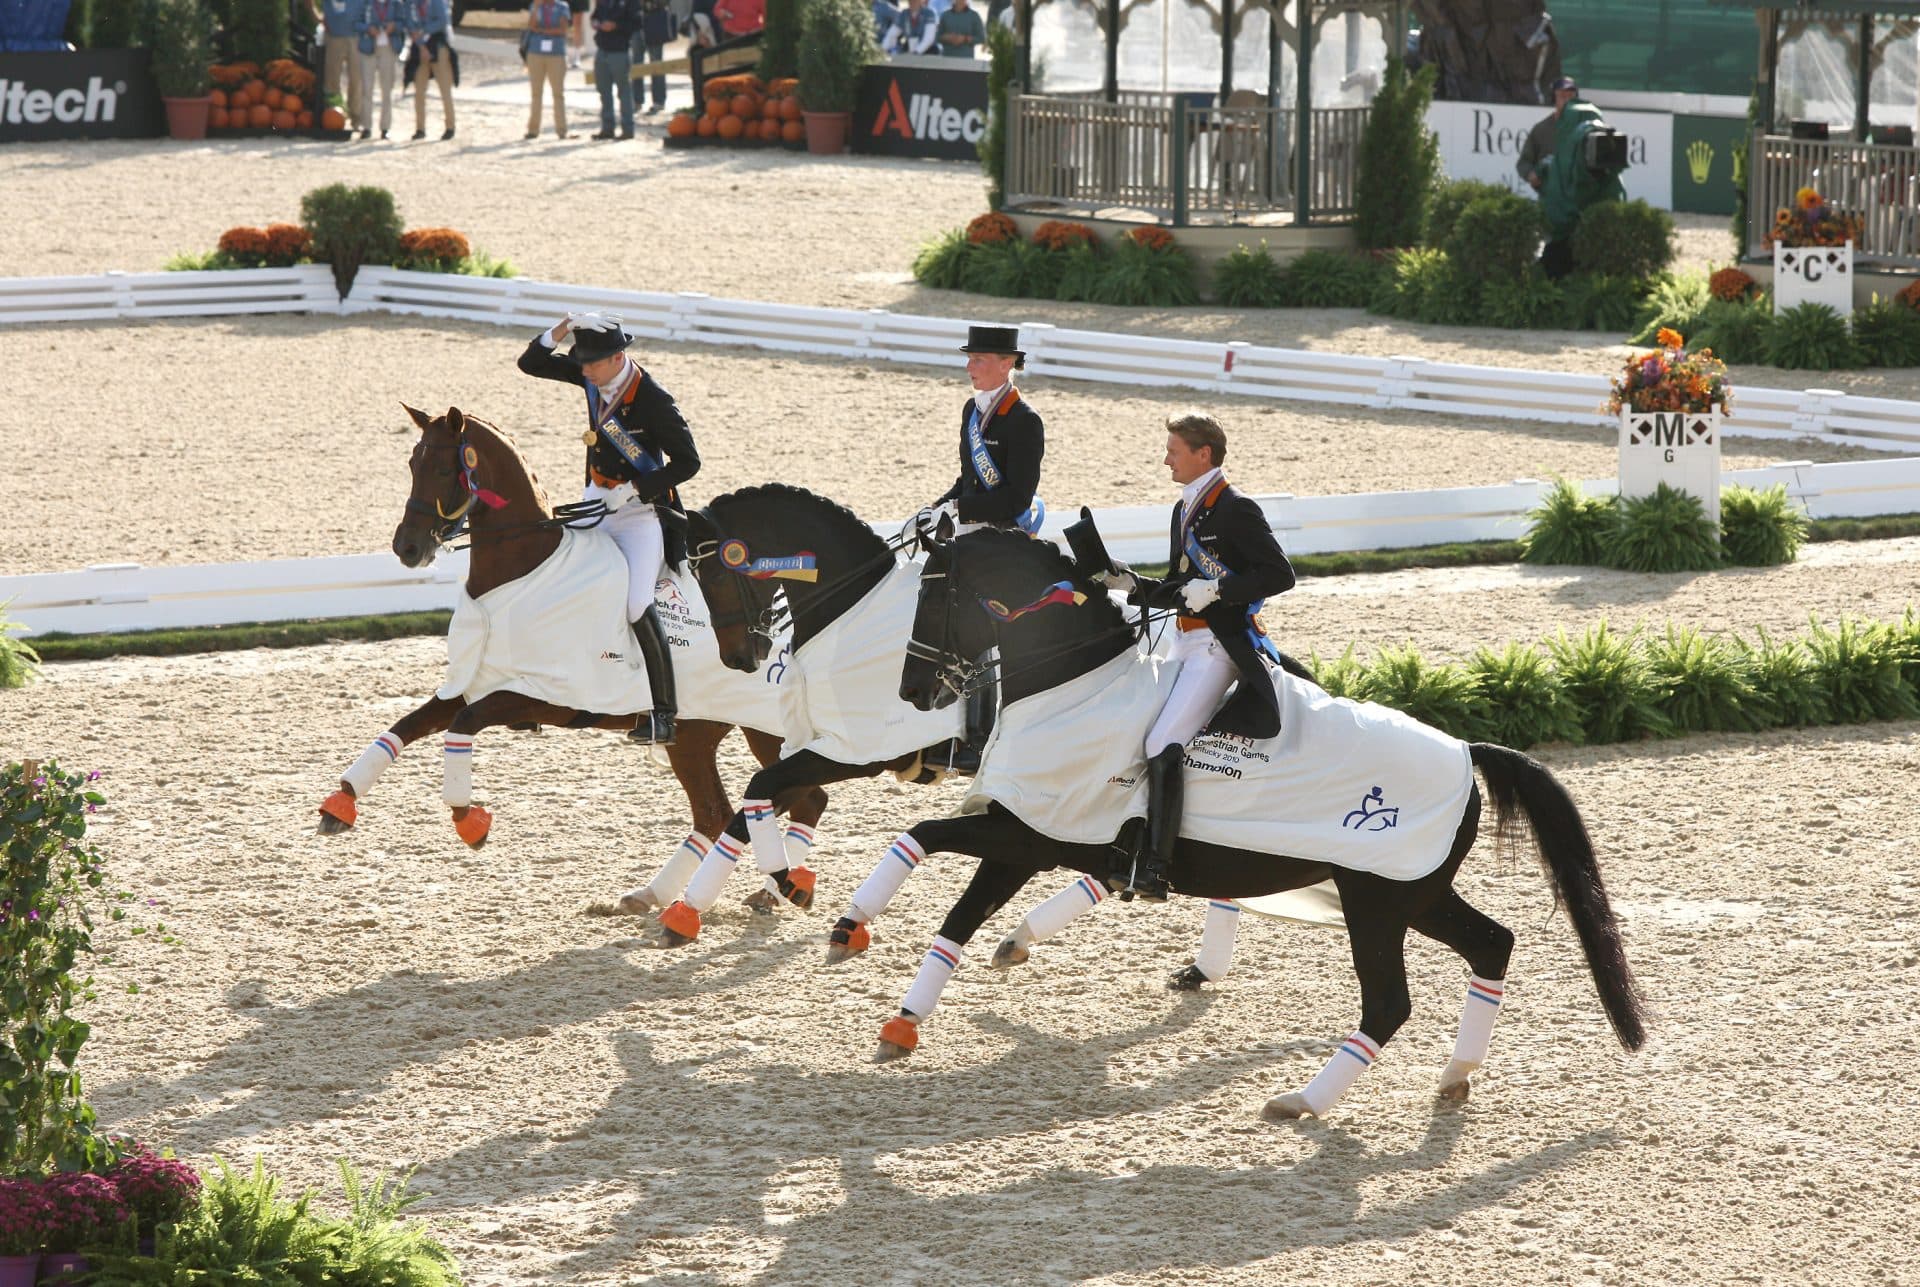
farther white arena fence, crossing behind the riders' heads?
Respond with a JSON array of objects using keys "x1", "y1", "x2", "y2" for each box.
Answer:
[{"x1": 0, "y1": 265, "x2": 1920, "y2": 453}]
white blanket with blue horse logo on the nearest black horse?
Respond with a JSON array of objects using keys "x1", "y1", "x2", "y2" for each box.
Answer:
[{"x1": 960, "y1": 651, "x2": 1473, "y2": 880}]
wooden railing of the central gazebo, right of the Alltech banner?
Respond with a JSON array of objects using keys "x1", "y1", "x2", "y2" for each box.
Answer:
[{"x1": 1006, "y1": 92, "x2": 1367, "y2": 225}]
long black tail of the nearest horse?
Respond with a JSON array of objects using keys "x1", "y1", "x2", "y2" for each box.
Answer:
[{"x1": 1471, "y1": 741, "x2": 1647, "y2": 1051}]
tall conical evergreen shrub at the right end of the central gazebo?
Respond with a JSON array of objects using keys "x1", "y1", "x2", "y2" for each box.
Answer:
[{"x1": 1354, "y1": 58, "x2": 1440, "y2": 250}]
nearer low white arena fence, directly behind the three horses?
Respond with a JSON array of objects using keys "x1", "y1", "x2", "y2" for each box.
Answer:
[{"x1": 11, "y1": 457, "x2": 1920, "y2": 636}]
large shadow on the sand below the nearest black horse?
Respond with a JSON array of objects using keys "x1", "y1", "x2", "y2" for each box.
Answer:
[{"x1": 417, "y1": 997, "x2": 1611, "y2": 1285}]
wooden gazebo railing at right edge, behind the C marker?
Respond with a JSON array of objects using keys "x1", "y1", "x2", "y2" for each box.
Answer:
[{"x1": 1747, "y1": 134, "x2": 1920, "y2": 267}]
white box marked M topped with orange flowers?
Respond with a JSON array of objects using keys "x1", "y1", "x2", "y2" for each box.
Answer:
[{"x1": 1607, "y1": 327, "x2": 1734, "y2": 522}]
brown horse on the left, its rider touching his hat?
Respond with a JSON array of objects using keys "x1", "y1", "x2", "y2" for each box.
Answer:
[{"x1": 319, "y1": 407, "x2": 828, "y2": 875}]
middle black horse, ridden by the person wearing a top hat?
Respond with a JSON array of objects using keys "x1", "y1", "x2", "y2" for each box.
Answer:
[{"x1": 655, "y1": 482, "x2": 975, "y2": 947}]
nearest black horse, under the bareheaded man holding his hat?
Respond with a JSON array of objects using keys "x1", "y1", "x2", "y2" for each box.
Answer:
[{"x1": 879, "y1": 530, "x2": 1645, "y2": 1118}]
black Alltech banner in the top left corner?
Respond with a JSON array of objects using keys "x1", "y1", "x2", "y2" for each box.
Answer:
[{"x1": 0, "y1": 50, "x2": 167, "y2": 142}]
